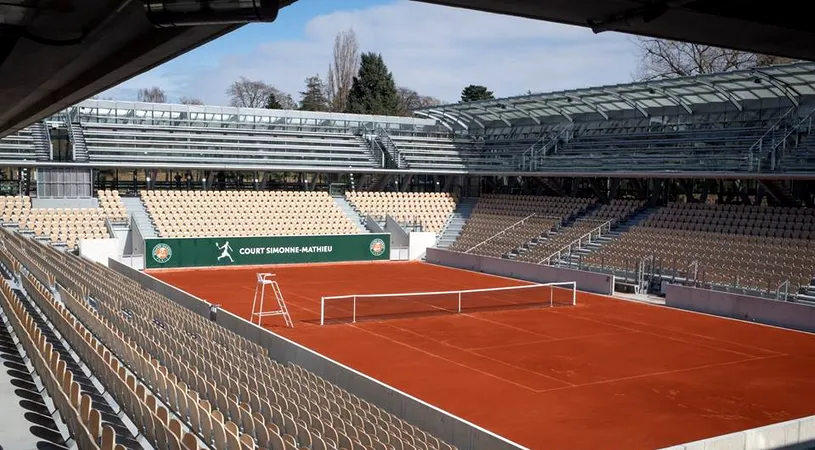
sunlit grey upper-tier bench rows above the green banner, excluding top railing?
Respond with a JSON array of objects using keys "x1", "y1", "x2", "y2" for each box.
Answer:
[{"x1": 80, "y1": 122, "x2": 377, "y2": 168}]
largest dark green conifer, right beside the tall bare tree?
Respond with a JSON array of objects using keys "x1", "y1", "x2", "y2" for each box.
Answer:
[{"x1": 346, "y1": 53, "x2": 401, "y2": 116}]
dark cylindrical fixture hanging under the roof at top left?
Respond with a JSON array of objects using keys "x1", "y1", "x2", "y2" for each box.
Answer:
[{"x1": 144, "y1": 0, "x2": 280, "y2": 28}]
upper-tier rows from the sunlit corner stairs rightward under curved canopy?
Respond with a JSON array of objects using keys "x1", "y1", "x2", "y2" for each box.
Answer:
[{"x1": 390, "y1": 109, "x2": 785, "y2": 172}]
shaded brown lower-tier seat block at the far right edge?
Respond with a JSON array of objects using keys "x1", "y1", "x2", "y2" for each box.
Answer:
[{"x1": 583, "y1": 203, "x2": 815, "y2": 290}]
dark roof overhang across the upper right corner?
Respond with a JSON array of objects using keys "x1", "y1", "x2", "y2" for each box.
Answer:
[{"x1": 417, "y1": 0, "x2": 815, "y2": 61}]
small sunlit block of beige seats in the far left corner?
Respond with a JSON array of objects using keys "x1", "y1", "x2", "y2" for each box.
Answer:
[{"x1": 0, "y1": 194, "x2": 127, "y2": 248}]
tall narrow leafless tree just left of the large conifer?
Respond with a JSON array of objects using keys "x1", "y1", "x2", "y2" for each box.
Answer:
[{"x1": 326, "y1": 28, "x2": 359, "y2": 111}]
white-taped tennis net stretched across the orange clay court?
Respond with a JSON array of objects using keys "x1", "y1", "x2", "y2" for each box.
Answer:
[{"x1": 320, "y1": 281, "x2": 577, "y2": 325}]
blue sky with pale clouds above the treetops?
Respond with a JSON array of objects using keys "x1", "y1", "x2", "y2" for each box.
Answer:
[{"x1": 99, "y1": 0, "x2": 637, "y2": 105}]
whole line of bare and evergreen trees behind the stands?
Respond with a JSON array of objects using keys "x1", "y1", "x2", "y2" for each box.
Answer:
[{"x1": 129, "y1": 29, "x2": 791, "y2": 116}]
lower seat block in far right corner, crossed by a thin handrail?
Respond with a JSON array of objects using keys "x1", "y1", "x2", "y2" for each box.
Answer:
[{"x1": 449, "y1": 194, "x2": 593, "y2": 257}]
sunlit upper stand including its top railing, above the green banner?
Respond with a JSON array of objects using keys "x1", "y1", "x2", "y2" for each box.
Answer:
[{"x1": 70, "y1": 100, "x2": 440, "y2": 168}]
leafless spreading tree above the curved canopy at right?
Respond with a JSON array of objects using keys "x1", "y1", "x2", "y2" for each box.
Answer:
[{"x1": 634, "y1": 37, "x2": 793, "y2": 81}]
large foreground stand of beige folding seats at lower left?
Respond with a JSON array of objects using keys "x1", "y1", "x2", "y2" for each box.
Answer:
[{"x1": 0, "y1": 230, "x2": 460, "y2": 450}]
